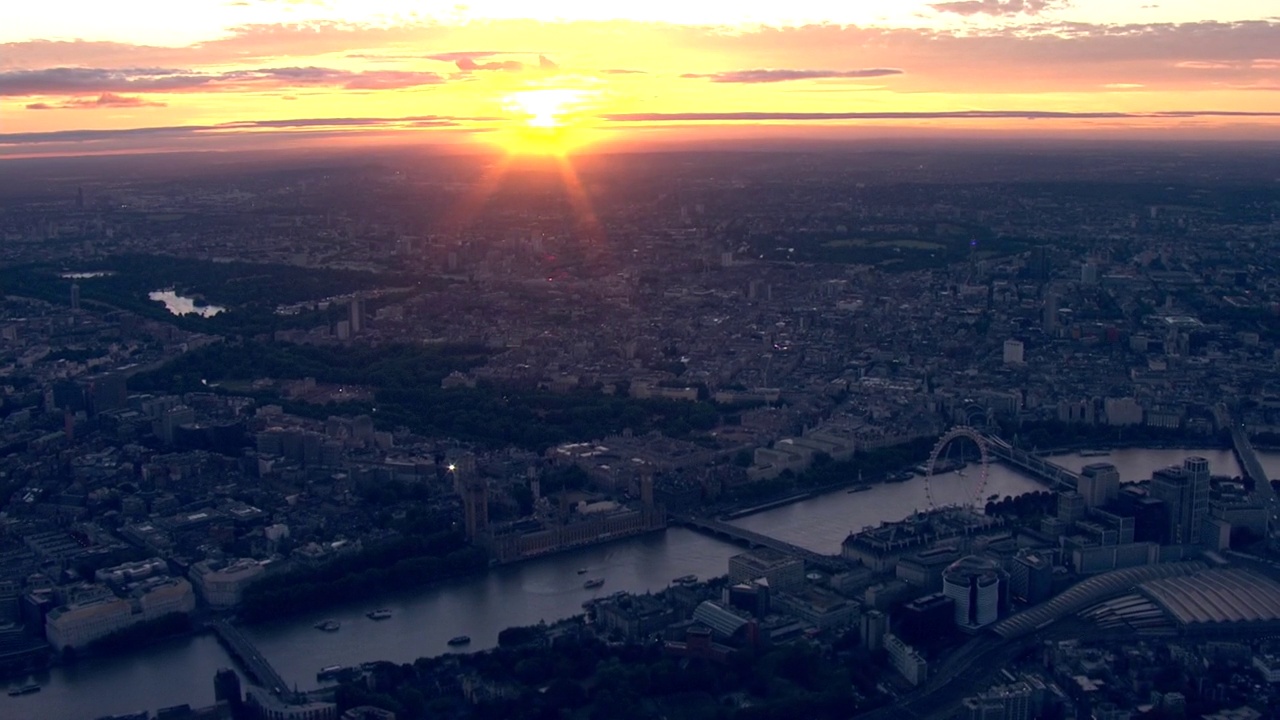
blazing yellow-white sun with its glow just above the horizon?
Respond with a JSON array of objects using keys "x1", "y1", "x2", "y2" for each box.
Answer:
[{"x1": 500, "y1": 87, "x2": 601, "y2": 155}]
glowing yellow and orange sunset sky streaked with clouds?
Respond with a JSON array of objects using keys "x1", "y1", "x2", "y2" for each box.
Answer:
[{"x1": 0, "y1": 0, "x2": 1280, "y2": 156}]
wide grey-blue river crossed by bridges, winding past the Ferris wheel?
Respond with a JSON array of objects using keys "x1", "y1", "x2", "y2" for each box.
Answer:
[{"x1": 17, "y1": 448, "x2": 1280, "y2": 720}]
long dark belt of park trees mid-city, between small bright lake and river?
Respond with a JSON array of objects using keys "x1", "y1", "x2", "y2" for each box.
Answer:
[{"x1": 129, "y1": 340, "x2": 722, "y2": 451}]
